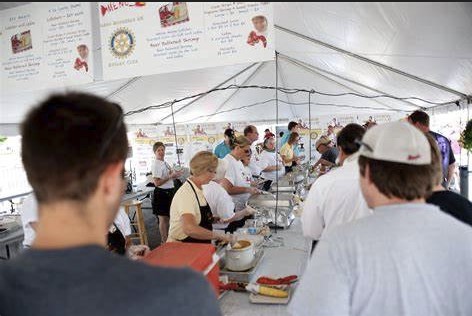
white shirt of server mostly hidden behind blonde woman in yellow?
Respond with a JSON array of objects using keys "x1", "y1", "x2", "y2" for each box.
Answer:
[{"x1": 202, "y1": 181, "x2": 234, "y2": 229}]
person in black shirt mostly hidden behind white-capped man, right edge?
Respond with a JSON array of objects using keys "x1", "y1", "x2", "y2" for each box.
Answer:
[{"x1": 425, "y1": 133, "x2": 472, "y2": 226}]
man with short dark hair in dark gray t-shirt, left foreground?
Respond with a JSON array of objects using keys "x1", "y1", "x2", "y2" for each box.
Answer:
[{"x1": 0, "y1": 93, "x2": 221, "y2": 316}]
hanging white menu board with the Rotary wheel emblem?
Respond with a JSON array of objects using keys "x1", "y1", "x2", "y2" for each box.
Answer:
[{"x1": 98, "y1": 2, "x2": 275, "y2": 80}]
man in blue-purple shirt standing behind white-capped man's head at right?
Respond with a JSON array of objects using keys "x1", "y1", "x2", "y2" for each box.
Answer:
[{"x1": 408, "y1": 110, "x2": 456, "y2": 189}]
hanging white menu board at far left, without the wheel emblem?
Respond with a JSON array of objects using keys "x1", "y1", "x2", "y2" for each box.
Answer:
[{"x1": 0, "y1": 2, "x2": 93, "y2": 93}]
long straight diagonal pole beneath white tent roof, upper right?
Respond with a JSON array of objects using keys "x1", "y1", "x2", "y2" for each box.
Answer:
[{"x1": 275, "y1": 25, "x2": 467, "y2": 98}]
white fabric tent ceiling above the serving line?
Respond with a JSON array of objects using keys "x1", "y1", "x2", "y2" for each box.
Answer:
[{"x1": 0, "y1": 2, "x2": 472, "y2": 124}]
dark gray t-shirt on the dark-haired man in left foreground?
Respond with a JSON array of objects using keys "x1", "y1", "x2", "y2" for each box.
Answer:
[{"x1": 0, "y1": 246, "x2": 220, "y2": 316}]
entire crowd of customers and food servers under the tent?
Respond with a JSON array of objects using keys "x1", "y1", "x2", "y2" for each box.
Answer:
[{"x1": 0, "y1": 93, "x2": 472, "y2": 316}]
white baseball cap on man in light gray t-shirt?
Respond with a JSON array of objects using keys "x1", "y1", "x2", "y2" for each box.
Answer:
[{"x1": 359, "y1": 121, "x2": 431, "y2": 165}]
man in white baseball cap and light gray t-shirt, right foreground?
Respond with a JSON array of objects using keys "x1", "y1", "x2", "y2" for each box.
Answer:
[{"x1": 289, "y1": 122, "x2": 472, "y2": 316}]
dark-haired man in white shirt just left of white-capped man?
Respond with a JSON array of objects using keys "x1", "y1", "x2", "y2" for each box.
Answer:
[{"x1": 301, "y1": 124, "x2": 371, "y2": 251}]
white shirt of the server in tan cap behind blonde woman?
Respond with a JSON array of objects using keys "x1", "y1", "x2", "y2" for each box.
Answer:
[{"x1": 223, "y1": 154, "x2": 251, "y2": 212}]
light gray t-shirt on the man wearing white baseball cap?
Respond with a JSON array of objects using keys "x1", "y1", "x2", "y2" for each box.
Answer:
[{"x1": 289, "y1": 204, "x2": 472, "y2": 316}]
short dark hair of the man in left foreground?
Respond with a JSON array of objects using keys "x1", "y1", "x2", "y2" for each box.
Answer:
[{"x1": 21, "y1": 93, "x2": 128, "y2": 203}]
